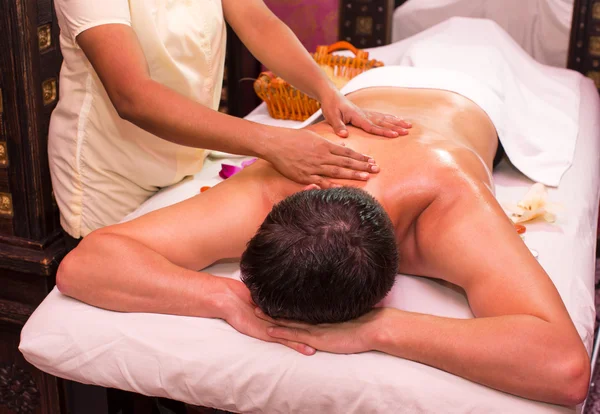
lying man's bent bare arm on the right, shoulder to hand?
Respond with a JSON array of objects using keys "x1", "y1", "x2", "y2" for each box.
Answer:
[{"x1": 261, "y1": 174, "x2": 590, "y2": 405}]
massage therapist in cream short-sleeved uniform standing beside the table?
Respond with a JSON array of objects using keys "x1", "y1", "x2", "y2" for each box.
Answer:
[{"x1": 49, "y1": 0, "x2": 409, "y2": 238}]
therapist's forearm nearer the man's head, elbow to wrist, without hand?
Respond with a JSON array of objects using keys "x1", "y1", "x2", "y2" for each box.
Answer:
[{"x1": 115, "y1": 79, "x2": 285, "y2": 157}]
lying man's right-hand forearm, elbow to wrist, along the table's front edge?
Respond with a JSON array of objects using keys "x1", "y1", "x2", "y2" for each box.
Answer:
[{"x1": 373, "y1": 309, "x2": 589, "y2": 405}]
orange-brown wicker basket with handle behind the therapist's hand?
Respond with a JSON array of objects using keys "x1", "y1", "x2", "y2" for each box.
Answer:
[{"x1": 254, "y1": 41, "x2": 383, "y2": 121}]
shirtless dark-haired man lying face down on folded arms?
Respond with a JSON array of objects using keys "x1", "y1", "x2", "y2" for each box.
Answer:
[{"x1": 57, "y1": 75, "x2": 590, "y2": 405}]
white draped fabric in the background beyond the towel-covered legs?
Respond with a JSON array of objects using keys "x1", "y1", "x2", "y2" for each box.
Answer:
[{"x1": 392, "y1": 0, "x2": 573, "y2": 67}]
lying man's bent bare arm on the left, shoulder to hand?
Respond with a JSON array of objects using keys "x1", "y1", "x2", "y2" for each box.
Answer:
[{"x1": 56, "y1": 165, "x2": 314, "y2": 350}]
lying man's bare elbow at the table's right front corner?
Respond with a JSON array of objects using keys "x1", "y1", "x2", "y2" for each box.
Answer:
[{"x1": 559, "y1": 350, "x2": 591, "y2": 406}]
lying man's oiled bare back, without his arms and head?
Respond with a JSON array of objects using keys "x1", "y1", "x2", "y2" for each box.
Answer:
[{"x1": 236, "y1": 88, "x2": 498, "y2": 273}]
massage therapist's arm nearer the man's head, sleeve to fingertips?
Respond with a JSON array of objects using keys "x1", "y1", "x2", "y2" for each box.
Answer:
[{"x1": 77, "y1": 24, "x2": 378, "y2": 187}]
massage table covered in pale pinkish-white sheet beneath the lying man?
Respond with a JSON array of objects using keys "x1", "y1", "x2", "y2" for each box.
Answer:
[{"x1": 20, "y1": 17, "x2": 600, "y2": 414}]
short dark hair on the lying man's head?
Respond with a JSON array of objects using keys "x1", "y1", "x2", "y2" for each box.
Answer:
[{"x1": 241, "y1": 187, "x2": 398, "y2": 324}]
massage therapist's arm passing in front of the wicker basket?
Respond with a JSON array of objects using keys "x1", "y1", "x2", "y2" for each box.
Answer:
[{"x1": 223, "y1": 0, "x2": 411, "y2": 138}]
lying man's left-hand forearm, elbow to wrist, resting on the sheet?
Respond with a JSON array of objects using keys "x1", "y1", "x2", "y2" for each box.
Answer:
[{"x1": 56, "y1": 231, "x2": 229, "y2": 318}]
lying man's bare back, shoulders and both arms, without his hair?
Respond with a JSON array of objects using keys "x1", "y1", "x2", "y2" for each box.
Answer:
[{"x1": 57, "y1": 88, "x2": 589, "y2": 405}]
